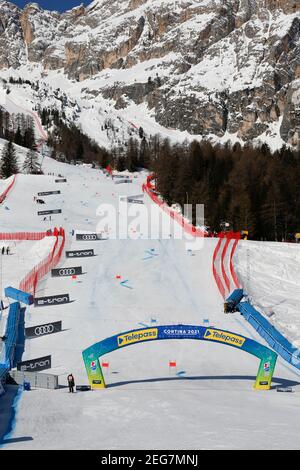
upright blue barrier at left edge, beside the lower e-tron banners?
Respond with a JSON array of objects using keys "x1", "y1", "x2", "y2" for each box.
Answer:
[{"x1": 0, "y1": 302, "x2": 21, "y2": 388}]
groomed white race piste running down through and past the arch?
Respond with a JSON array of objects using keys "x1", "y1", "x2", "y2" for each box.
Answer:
[{"x1": 0, "y1": 157, "x2": 300, "y2": 450}]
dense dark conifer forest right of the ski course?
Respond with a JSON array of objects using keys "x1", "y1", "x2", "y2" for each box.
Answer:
[{"x1": 151, "y1": 140, "x2": 300, "y2": 241}]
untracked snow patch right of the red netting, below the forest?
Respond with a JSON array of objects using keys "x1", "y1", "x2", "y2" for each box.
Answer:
[{"x1": 235, "y1": 241, "x2": 300, "y2": 348}]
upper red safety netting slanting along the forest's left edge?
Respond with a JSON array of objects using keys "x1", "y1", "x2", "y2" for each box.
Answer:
[{"x1": 142, "y1": 175, "x2": 207, "y2": 237}]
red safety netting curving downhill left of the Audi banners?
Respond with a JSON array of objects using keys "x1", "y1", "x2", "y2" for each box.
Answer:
[{"x1": 19, "y1": 228, "x2": 65, "y2": 295}]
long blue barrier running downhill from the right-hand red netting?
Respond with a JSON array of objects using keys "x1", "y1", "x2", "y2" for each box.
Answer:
[{"x1": 237, "y1": 302, "x2": 300, "y2": 369}]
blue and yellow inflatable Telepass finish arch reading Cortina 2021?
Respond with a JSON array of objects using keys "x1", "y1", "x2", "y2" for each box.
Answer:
[{"x1": 82, "y1": 325, "x2": 277, "y2": 390}]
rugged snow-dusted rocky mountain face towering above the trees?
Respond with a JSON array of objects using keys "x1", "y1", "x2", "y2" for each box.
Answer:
[{"x1": 0, "y1": 0, "x2": 300, "y2": 145}]
